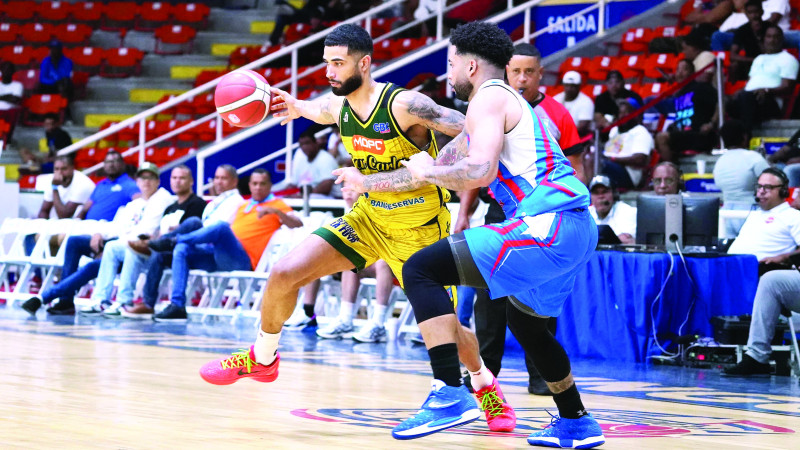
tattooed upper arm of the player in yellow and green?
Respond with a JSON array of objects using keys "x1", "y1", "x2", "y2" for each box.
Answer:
[{"x1": 392, "y1": 91, "x2": 464, "y2": 136}]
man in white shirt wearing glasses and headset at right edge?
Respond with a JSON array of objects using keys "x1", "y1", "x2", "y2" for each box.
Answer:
[{"x1": 728, "y1": 168, "x2": 800, "y2": 273}]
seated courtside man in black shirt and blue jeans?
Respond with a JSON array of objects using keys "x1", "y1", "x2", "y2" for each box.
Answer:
[{"x1": 114, "y1": 164, "x2": 206, "y2": 319}]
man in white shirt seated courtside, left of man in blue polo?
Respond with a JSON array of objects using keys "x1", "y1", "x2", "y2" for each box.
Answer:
[{"x1": 38, "y1": 156, "x2": 94, "y2": 219}]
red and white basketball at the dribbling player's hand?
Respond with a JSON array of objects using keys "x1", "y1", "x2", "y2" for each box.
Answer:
[{"x1": 214, "y1": 69, "x2": 270, "y2": 127}]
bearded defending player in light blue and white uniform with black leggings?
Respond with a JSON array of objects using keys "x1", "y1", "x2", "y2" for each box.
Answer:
[{"x1": 332, "y1": 22, "x2": 605, "y2": 448}]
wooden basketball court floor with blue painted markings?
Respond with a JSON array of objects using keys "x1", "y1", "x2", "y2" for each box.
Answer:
[{"x1": 0, "y1": 308, "x2": 800, "y2": 449}]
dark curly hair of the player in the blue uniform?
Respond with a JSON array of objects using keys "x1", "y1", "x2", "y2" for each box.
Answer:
[{"x1": 450, "y1": 22, "x2": 514, "y2": 70}]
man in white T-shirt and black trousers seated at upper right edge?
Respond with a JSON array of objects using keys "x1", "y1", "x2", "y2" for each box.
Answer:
[{"x1": 729, "y1": 23, "x2": 798, "y2": 137}]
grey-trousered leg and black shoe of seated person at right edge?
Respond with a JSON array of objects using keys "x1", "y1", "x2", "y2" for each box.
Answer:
[{"x1": 721, "y1": 269, "x2": 800, "y2": 377}]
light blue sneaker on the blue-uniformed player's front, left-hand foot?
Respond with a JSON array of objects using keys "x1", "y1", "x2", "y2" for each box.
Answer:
[{"x1": 392, "y1": 380, "x2": 482, "y2": 439}]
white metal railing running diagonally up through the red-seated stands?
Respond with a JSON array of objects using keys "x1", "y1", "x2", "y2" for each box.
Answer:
[{"x1": 58, "y1": 0, "x2": 622, "y2": 195}]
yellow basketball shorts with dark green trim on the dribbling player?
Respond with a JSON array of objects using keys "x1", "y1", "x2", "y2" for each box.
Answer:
[{"x1": 314, "y1": 203, "x2": 450, "y2": 287}]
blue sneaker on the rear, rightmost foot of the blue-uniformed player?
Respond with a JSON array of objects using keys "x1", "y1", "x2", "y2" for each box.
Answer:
[{"x1": 528, "y1": 413, "x2": 606, "y2": 448}]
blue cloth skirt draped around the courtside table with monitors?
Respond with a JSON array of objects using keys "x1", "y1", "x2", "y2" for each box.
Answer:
[{"x1": 556, "y1": 251, "x2": 758, "y2": 362}]
